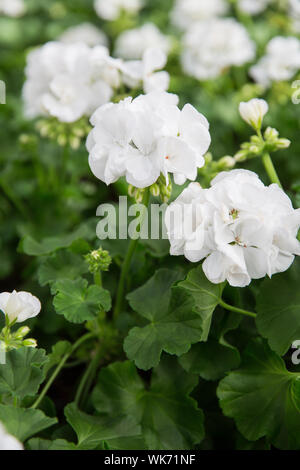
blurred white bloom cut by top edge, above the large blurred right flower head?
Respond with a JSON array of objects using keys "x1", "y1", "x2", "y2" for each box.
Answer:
[{"x1": 171, "y1": 0, "x2": 228, "y2": 30}]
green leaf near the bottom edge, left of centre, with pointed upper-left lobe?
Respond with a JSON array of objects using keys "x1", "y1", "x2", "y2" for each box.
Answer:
[{"x1": 65, "y1": 403, "x2": 141, "y2": 450}]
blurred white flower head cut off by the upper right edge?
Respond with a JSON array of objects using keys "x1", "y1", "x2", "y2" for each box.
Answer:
[{"x1": 250, "y1": 36, "x2": 300, "y2": 87}]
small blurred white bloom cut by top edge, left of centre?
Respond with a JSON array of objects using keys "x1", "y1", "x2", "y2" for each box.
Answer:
[{"x1": 94, "y1": 0, "x2": 143, "y2": 21}]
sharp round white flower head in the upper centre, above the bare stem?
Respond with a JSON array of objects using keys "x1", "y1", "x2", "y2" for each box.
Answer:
[{"x1": 87, "y1": 92, "x2": 210, "y2": 188}]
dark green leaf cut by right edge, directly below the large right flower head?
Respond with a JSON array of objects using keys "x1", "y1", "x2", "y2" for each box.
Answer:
[{"x1": 256, "y1": 259, "x2": 300, "y2": 356}]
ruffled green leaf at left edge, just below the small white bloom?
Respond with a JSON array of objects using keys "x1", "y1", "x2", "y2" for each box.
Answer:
[{"x1": 0, "y1": 347, "x2": 48, "y2": 399}]
